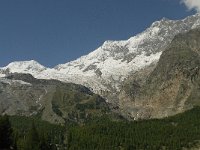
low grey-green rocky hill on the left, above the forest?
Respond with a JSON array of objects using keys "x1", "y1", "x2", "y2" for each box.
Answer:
[{"x1": 0, "y1": 74, "x2": 109, "y2": 123}]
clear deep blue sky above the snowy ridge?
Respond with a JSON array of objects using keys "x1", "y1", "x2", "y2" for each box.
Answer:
[{"x1": 0, "y1": 0, "x2": 195, "y2": 67}]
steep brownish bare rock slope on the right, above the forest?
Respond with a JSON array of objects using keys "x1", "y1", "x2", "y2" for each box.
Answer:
[{"x1": 120, "y1": 29, "x2": 200, "y2": 119}]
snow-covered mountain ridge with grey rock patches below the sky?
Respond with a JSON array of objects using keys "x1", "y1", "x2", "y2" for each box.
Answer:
[{"x1": 0, "y1": 14, "x2": 200, "y2": 97}]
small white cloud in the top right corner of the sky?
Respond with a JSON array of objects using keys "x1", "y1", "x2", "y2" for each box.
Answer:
[{"x1": 181, "y1": 0, "x2": 200, "y2": 12}]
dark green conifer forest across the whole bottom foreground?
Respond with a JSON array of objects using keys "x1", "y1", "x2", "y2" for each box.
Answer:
[{"x1": 0, "y1": 107, "x2": 200, "y2": 150}]
